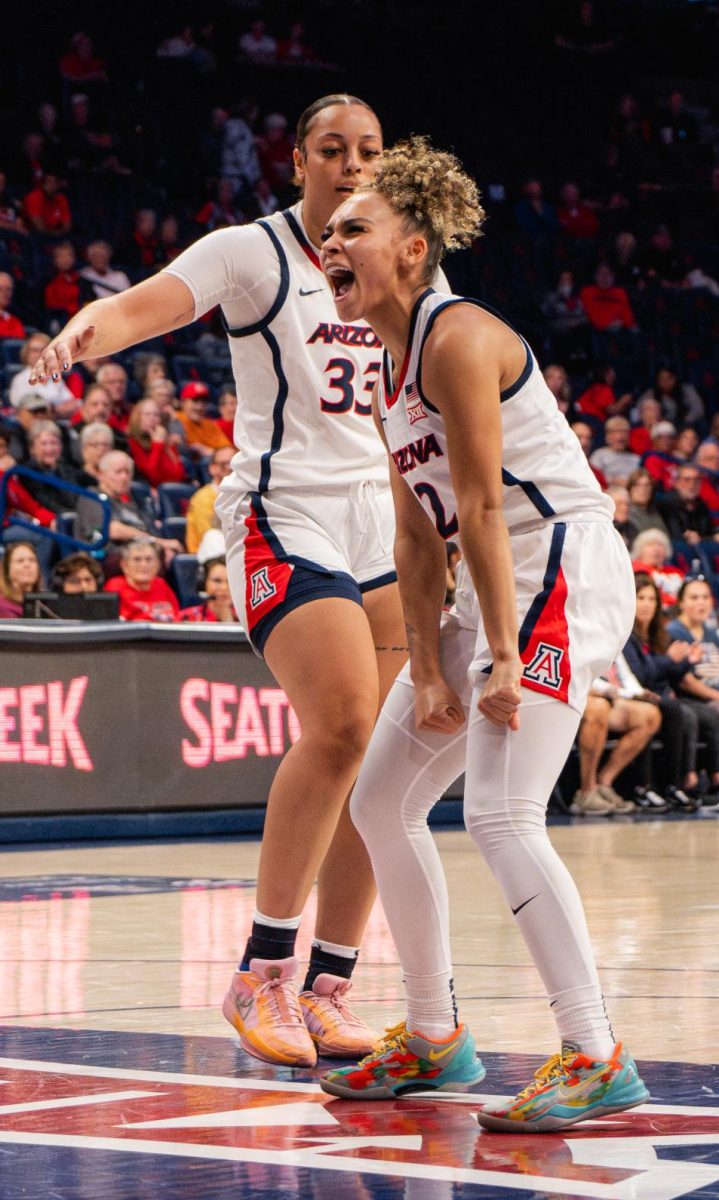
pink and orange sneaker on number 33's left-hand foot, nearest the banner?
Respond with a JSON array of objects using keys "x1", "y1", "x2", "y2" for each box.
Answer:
[{"x1": 222, "y1": 958, "x2": 317, "y2": 1067}]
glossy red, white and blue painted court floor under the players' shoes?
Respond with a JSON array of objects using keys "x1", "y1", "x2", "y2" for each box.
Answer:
[{"x1": 0, "y1": 1027, "x2": 719, "y2": 1200}]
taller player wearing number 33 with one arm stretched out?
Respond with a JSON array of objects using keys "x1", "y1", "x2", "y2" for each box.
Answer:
[{"x1": 34, "y1": 95, "x2": 415, "y2": 1067}]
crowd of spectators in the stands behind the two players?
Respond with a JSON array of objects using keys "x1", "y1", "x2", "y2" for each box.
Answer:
[{"x1": 0, "y1": 4, "x2": 719, "y2": 815}]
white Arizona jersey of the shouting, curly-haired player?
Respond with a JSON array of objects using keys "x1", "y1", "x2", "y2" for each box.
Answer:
[{"x1": 378, "y1": 289, "x2": 613, "y2": 541}]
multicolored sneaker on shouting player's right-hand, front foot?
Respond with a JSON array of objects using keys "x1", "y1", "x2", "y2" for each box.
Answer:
[{"x1": 477, "y1": 1042, "x2": 649, "y2": 1133}]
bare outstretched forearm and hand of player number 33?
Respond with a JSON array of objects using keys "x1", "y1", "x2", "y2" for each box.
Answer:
[{"x1": 30, "y1": 272, "x2": 194, "y2": 384}]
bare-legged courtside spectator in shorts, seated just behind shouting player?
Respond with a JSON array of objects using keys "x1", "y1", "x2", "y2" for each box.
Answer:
[{"x1": 570, "y1": 679, "x2": 665, "y2": 816}]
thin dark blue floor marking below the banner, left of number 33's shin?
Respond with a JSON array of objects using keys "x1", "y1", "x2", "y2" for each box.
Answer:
[{"x1": 0, "y1": 875, "x2": 257, "y2": 902}]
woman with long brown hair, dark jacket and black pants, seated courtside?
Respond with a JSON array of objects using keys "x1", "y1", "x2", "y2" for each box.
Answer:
[{"x1": 624, "y1": 572, "x2": 699, "y2": 812}]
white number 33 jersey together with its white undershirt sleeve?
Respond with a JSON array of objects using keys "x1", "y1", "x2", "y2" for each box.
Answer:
[{"x1": 166, "y1": 204, "x2": 388, "y2": 494}]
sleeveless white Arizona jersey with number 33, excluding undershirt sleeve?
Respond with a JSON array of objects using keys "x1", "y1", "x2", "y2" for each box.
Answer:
[{"x1": 222, "y1": 205, "x2": 388, "y2": 493}]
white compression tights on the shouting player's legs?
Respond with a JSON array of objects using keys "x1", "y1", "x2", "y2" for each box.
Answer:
[{"x1": 350, "y1": 682, "x2": 613, "y2": 1058}]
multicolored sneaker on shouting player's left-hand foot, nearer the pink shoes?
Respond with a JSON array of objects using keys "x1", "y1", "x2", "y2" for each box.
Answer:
[{"x1": 319, "y1": 1021, "x2": 485, "y2": 1100}]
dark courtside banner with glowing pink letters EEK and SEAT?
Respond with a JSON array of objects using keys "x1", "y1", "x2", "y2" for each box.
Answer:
[{"x1": 0, "y1": 622, "x2": 300, "y2": 816}]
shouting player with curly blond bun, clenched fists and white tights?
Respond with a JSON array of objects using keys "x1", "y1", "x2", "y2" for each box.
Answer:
[{"x1": 322, "y1": 138, "x2": 648, "y2": 1133}]
